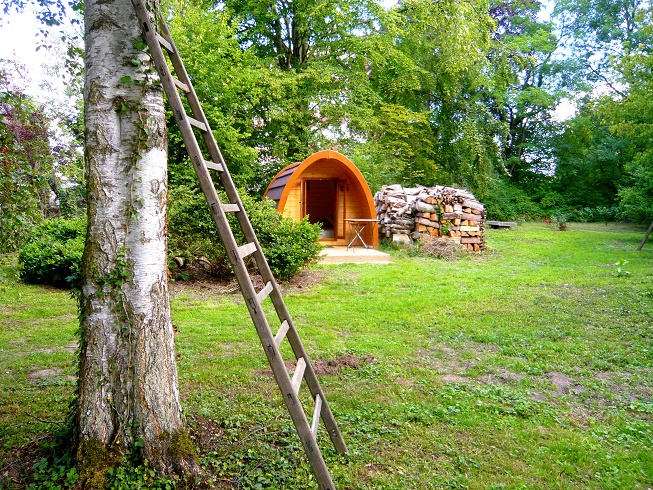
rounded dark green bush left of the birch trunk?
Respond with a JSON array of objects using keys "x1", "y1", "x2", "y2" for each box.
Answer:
[{"x1": 18, "y1": 218, "x2": 86, "y2": 286}]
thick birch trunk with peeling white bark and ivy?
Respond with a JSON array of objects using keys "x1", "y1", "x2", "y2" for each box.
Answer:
[{"x1": 77, "y1": 0, "x2": 198, "y2": 487}]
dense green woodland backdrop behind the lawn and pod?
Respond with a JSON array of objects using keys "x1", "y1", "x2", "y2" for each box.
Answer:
[{"x1": 0, "y1": 0, "x2": 653, "y2": 252}]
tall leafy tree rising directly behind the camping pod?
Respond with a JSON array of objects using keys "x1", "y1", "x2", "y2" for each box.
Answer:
[{"x1": 224, "y1": 0, "x2": 380, "y2": 163}]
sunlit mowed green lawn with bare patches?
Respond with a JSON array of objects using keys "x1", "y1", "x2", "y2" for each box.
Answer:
[{"x1": 0, "y1": 223, "x2": 653, "y2": 489}]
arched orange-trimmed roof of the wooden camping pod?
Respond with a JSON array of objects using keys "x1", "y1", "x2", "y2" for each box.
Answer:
[{"x1": 265, "y1": 150, "x2": 376, "y2": 218}]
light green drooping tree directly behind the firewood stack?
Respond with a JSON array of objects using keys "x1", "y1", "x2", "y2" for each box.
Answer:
[{"x1": 384, "y1": 0, "x2": 498, "y2": 196}]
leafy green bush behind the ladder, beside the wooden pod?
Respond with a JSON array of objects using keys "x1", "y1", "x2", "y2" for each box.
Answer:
[{"x1": 168, "y1": 186, "x2": 322, "y2": 279}]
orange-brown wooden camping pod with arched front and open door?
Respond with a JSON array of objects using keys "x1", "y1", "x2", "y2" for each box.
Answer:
[{"x1": 265, "y1": 150, "x2": 379, "y2": 249}]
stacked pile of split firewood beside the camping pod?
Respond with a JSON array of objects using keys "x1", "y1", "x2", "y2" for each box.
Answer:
[{"x1": 374, "y1": 185, "x2": 485, "y2": 252}]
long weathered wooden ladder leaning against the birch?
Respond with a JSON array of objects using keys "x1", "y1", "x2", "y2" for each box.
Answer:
[{"x1": 132, "y1": 0, "x2": 347, "y2": 490}]
